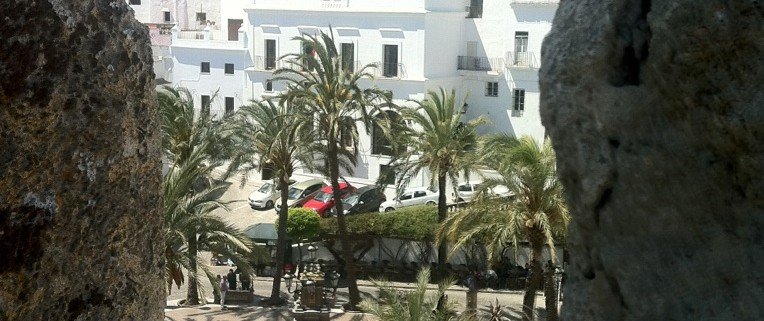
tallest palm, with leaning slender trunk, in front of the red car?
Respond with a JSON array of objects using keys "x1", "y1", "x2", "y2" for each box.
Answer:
[{"x1": 274, "y1": 31, "x2": 390, "y2": 308}]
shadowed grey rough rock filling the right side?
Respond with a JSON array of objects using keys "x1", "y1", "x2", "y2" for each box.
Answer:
[{"x1": 540, "y1": 0, "x2": 764, "y2": 321}]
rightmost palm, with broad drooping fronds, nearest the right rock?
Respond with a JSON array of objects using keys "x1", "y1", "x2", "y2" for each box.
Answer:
[{"x1": 438, "y1": 135, "x2": 570, "y2": 320}]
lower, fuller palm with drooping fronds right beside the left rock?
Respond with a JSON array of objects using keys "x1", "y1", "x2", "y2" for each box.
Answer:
[{"x1": 162, "y1": 152, "x2": 263, "y2": 305}]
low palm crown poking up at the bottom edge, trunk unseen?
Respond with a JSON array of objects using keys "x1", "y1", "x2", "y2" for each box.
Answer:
[{"x1": 361, "y1": 268, "x2": 456, "y2": 321}]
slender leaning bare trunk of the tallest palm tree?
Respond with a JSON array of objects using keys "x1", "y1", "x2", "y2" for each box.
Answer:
[{"x1": 328, "y1": 142, "x2": 361, "y2": 310}]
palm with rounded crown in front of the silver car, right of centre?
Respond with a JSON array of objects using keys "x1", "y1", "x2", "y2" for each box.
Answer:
[{"x1": 394, "y1": 88, "x2": 487, "y2": 277}]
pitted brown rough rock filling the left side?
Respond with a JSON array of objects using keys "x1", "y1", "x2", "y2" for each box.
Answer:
[{"x1": 0, "y1": 0, "x2": 164, "y2": 320}]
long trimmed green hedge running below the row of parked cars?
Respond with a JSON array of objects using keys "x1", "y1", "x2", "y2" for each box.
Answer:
[{"x1": 319, "y1": 205, "x2": 438, "y2": 241}]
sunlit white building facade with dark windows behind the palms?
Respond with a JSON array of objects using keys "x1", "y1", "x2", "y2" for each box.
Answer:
[{"x1": 139, "y1": 0, "x2": 558, "y2": 195}]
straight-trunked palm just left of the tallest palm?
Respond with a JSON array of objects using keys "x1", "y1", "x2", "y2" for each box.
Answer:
[{"x1": 227, "y1": 100, "x2": 313, "y2": 304}]
